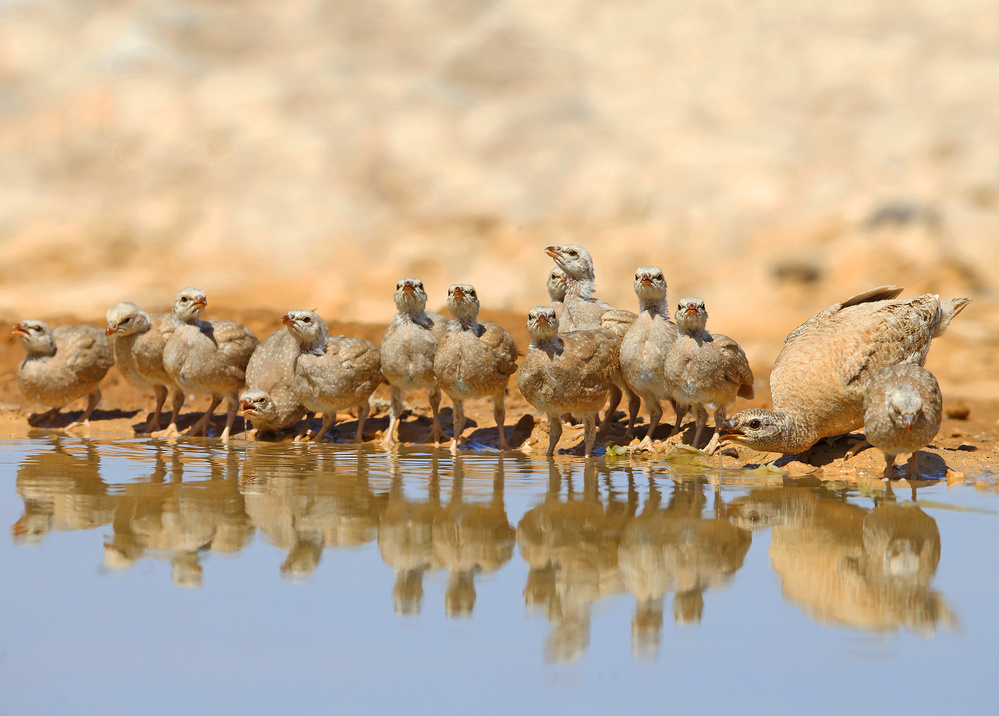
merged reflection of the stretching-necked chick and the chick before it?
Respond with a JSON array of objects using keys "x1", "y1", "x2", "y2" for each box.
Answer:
[{"x1": 517, "y1": 460, "x2": 638, "y2": 662}]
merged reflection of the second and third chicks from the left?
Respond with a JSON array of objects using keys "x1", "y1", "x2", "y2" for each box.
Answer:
[{"x1": 104, "y1": 443, "x2": 253, "y2": 587}]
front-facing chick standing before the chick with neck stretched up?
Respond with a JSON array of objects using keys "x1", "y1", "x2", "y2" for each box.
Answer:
[{"x1": 517, "y1": 306, "x2": 617, "y2": 457}]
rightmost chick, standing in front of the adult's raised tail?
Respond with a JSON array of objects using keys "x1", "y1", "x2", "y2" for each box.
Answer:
[{"x1": 864, "y1": 363, "x2": 943, "y2": 478}]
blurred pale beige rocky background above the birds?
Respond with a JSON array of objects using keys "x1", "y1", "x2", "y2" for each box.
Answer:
[{"x1": 0, "y1": 0, "x2": 999, "y2": 338}]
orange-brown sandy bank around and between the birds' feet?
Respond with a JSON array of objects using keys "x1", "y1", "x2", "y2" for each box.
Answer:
[{"x1": 0, "y1": 292, "x2": 999, "y2": 482}]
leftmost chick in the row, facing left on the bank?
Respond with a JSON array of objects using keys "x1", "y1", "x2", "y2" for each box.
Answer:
[{"x1": 11, "y1": 319, "x2": 114, "y2": 429}]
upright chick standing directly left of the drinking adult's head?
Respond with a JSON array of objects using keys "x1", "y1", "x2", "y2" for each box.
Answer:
[{"x1": 665, "y1": 298, "x2": 754, "y2": 452}]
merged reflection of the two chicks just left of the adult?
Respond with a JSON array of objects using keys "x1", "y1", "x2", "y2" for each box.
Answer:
[{"x1": 618, "y1": 477, "x2": 752, "y2": 658}]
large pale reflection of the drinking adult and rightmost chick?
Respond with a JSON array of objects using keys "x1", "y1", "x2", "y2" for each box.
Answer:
[{"x1": 730, "y1": 487, "x2": 957, "y2": 635}]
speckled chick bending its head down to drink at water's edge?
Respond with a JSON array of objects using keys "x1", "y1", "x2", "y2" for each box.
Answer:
[{"x1": 239, "y1": 326, "x2": 307, "y2": 434}]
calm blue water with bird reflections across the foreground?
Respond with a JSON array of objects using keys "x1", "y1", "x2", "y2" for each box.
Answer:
[{"x1": 0, "y1": 437, "x2": 999, "y2": 714}]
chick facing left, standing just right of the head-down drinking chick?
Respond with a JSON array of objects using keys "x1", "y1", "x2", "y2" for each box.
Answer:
[{"x1": 281, "y1": 311, "x2": 385, "y2": 442}]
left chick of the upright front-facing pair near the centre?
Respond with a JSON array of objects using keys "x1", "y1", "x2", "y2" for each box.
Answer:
[{"x1": 379, "y1": 278, "x2": 447, "y2": 444}]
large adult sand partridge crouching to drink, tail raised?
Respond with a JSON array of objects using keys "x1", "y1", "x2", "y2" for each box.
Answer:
[{"x1": 722, "y1": 286, "x2": 970, "y2": 454}]
